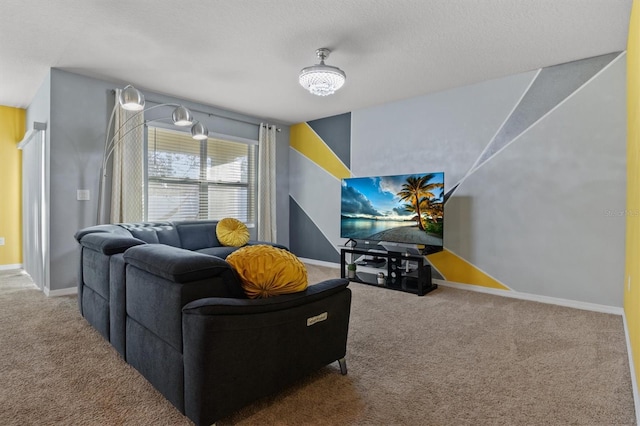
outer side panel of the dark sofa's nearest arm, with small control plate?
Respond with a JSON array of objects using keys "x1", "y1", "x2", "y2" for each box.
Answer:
[{"x1": 182, "y1": 279, "x2": 351, "y2": 424}]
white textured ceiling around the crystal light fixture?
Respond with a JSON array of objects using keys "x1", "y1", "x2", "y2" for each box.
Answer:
[{"x1": 0, "y1": 0, "x2": 632, "y2": 123}]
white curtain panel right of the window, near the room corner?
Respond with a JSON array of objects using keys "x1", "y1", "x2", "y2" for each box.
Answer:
[{"x1": 258, "y1": 123, "x2": 277, "y2": 242}]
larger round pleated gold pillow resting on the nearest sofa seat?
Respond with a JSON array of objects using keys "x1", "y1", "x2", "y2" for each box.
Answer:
[{"x1": 227, "y1": 244, "x2": 309, "y2": 299}]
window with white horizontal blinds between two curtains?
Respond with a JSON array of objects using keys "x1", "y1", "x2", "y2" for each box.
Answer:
[{"x1": 145, "y1": 127, "x2": 257, "y2": 226}]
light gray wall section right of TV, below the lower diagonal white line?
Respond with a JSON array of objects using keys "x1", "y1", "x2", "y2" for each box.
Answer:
[{"x1": 445, "y1": 54, "x2": 626, "y2": 307}]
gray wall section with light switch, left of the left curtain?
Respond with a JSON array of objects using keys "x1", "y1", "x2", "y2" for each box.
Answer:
[{"x1": 49, "y1": 69, "x2": 113, "y2": 290}]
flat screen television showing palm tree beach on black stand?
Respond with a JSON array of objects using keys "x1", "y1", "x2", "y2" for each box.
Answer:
[{"x1": 340, "y1": 172, "x2": 444, "y2": 254}]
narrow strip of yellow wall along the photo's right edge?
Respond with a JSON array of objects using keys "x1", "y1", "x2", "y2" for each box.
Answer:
[{"x1": 620, "y1": 0, "x2": 640, "y2": 394}]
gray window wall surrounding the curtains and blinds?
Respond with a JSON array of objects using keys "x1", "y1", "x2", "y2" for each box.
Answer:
[{"x1": 27, "y1": 69, "x2": 289, "y2": 291}]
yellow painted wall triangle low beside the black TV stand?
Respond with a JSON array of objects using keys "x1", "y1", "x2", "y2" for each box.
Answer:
[{"x1": 427, "y1": 249, "x2": 510, "y2": 290}]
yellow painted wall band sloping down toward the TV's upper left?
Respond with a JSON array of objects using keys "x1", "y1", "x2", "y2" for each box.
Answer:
[{"x1": 289, "y1": 123, "x2": 351, "y2": 180}]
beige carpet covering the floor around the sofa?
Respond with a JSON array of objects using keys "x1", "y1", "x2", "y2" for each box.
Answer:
[{"x1": 0, "y1": 265, "x2": 635, "y2": 425}]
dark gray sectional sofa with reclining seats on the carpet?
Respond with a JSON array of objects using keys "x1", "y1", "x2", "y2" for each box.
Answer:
[{"x1": 75, "y1": 221, "x2": 351, "y2": 425}]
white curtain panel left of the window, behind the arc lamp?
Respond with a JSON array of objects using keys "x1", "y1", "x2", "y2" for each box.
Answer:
[{"x1": 111, "y1": 89, "x2": 144, "y2": 223}]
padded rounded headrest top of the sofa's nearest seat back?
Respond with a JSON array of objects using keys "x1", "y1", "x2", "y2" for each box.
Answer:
[{"x1": 124, "y1": 244, "x2": 233, "y2": 283}]
